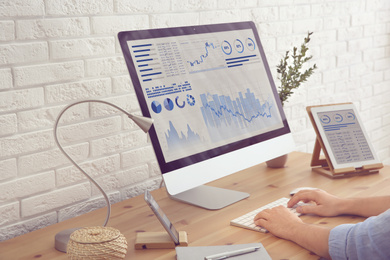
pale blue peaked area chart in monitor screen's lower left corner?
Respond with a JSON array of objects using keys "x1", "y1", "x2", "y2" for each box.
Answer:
[{"x1": 165, "y1": 121, "x2": 201, "y2": 152}]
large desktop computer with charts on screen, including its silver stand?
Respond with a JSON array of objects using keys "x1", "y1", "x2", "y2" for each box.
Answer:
[{"x1": 118, "y1": 22, "x2": 294, "y2": 209}]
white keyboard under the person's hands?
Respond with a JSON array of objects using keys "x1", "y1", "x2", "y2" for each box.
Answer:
[{"x1": 230, "y1": 198, "x2": 305, "y2": 233}]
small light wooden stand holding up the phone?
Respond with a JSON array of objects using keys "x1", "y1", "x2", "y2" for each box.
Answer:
[{"x1": 134, "y1": 231, "x2": 188, "y2": 249}]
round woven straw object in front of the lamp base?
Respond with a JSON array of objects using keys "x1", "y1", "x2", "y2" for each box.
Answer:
[{"x1": 67, "y1": 226, "x2": 127, "y2": 259}]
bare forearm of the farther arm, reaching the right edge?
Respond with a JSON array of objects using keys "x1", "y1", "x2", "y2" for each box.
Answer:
[{"x1": 340, "y1": 196, "x2": 390, "y2": 217}]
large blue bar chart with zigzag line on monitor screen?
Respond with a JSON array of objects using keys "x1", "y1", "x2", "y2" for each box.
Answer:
[{"x1": 200, "y1": 89, "x2": 280, "y2": 141}]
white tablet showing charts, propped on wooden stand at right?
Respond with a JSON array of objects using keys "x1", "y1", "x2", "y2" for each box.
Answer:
[{"x1": 308, "y1": 103, "x2": 381, "y2": 169}]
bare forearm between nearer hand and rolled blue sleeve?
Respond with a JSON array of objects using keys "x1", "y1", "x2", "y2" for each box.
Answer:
[{"x1": 286, "y1": 223, "x2": 330, "y2": 259}]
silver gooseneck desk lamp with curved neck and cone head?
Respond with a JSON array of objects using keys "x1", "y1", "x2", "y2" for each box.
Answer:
[{"x1": 54, "y1": 100, "x2": 153, "y2": 252}]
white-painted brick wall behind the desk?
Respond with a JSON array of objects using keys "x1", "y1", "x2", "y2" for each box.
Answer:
[{"x1": 0, "y1": 0, "x2": 390, "y2": 241}]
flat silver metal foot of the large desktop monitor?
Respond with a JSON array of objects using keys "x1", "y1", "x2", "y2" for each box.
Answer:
[{"x1": 168, "y1": 185, "x2": 249, "y2": 210}]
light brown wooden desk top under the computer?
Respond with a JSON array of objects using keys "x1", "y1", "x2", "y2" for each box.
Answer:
[{"x1": 0, "y1": 152, "x2": 390, "y2": 260}]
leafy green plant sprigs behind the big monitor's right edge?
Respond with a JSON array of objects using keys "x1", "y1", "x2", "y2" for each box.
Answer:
[{"x1": 276, "y1": 32, "x2": 317, "y2": 105}]
